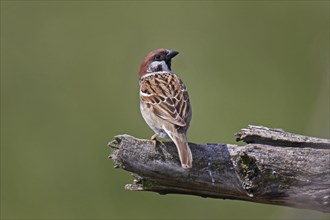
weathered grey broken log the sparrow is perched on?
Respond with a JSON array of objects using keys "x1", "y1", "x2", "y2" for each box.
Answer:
[{"x1": 109, "y1": 126, "x2": 330, "y2": 212}]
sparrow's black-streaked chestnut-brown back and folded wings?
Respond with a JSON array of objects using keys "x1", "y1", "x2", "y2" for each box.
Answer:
[{"x1": 140, "y1": 73, "x2": 191, "y2": 127}]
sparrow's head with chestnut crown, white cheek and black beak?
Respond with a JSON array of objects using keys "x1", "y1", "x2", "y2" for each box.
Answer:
[{"x1": 139, "y1": 48, "x2": 179, "y2": 78}]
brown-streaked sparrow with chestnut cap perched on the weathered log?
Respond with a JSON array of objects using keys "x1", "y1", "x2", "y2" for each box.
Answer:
[{"x1": 139, "y1": 49, "x2": 193, "y2": 168}]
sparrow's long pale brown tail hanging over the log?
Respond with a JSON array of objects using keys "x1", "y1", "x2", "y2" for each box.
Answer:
[{"x1": 172, "y1": 133, "x2": 193, "y2": 168}]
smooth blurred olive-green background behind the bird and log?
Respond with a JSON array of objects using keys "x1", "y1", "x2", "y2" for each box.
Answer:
[{"x1": 1, "y1": 1, "x2": 329, "y2": 219}]
